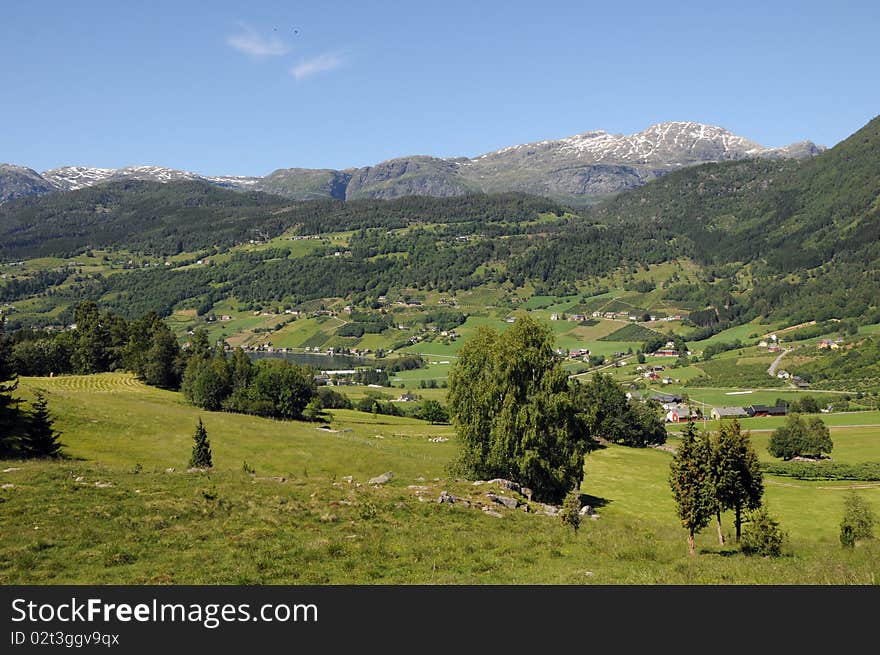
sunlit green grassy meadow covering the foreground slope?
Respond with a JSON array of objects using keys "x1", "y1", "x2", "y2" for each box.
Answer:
[{"x1": 0, "y1": 373, "x2": 880, "y2": 584}]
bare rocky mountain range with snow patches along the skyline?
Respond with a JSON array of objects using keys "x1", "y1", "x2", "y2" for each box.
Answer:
[{"x1": 0, "y1": 121, "x2": 825, "y2": 205}]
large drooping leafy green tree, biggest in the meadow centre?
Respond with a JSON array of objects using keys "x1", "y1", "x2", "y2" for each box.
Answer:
[{"x1": 449, "y1": 317, "x2": 592, "y2": 502}]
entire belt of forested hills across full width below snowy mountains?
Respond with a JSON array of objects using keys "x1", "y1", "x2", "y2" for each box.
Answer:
[{"x1": 0, "y1": 118, "x2": 880, "y2": 333}]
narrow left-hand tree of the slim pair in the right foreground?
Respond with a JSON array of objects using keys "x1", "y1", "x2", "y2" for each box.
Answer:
[{"x1": 669, "y1": 422, "x2": 716, "y2": 555}]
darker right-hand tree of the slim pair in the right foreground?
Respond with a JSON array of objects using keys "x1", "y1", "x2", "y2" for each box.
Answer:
[{"x1": 712, "y1": 419, "x2": 764, "y2": 545}]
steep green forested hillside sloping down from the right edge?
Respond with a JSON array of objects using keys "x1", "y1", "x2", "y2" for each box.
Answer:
[{"x1": 524, "y1": 118, "x2": 880, "y2": 321}]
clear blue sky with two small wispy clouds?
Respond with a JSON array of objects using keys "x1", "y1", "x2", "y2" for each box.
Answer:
[{"x1": 0, "y1": 0, "x2": 880, "y2": 175}]
